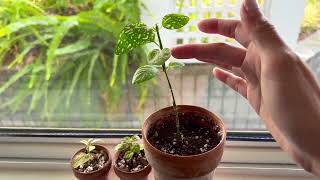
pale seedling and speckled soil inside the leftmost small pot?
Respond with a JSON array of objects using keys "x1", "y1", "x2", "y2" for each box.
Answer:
[{"x1": 72, "y1": 139, "x2": 109, "y2": 173}]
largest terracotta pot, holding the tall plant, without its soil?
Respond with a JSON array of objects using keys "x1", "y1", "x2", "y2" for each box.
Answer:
[{"x1": 142, "y1": 105, "x2": 226, "y2": 180}]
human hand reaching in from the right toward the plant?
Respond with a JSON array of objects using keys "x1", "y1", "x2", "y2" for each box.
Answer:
[{"x1": 172, "y1": 0, "x2": 320, "y2": 174}]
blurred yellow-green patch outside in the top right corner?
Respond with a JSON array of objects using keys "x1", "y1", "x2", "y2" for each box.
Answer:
[{"x1": 299, "y1": 0, "x2": 320, "y2": 39}]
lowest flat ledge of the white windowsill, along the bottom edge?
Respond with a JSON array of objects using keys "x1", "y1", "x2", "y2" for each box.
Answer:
[{"x1": 0, "y1": 159, "x2": 316, "y2": 180}]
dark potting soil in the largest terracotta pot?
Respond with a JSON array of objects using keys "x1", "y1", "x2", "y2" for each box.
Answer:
[{"x1": 148, "y1": 112, "x2": 222, "y2": 156}]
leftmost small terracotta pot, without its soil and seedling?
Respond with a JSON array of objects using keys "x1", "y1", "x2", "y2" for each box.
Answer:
[{"x1": 71, "y1": 145, "x2": 111, "y2": 180}]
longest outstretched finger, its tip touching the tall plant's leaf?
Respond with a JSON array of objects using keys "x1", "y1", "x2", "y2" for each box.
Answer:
[{"x1": 171, "y1": 43, "x2": 246, "y2": 67}]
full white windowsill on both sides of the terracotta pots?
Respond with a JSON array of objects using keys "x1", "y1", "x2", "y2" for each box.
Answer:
[{"x1": 0, "y1": 137, "x2": 315, "y2": 180}]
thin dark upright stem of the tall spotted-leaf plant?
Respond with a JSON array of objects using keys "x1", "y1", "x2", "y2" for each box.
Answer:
[{"x1": 156, "y1": 24, "x2": 182, "y2": 139}]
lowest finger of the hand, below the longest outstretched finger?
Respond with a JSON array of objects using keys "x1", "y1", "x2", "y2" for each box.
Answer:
[{"x1": 213, "y1": 68, "x2": 247, "y2": 98}]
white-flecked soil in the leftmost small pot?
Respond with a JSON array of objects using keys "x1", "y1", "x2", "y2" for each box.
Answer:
[{"x1": 77, "y1": 150, "x2": 109, "y2": 173}]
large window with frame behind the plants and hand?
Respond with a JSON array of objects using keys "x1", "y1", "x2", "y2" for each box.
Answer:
[{"x1": 0, "y1": 0, "x2": 320, "y2": 179}]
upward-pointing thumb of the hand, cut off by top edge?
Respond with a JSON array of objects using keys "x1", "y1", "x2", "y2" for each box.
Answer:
[{"x1": 241, "y1": 0, "x2": 286, "y2": 50}]
